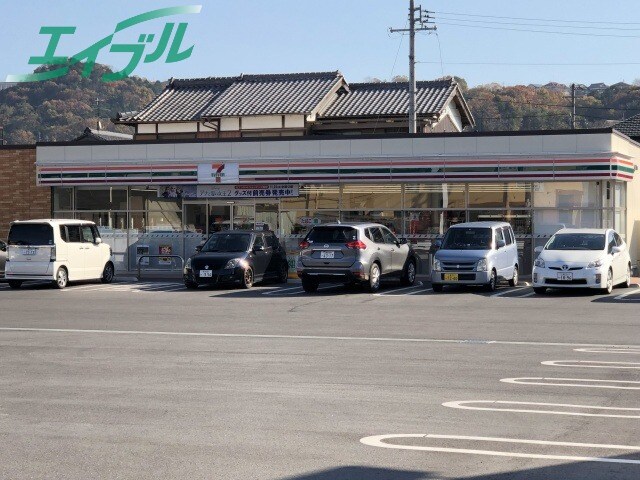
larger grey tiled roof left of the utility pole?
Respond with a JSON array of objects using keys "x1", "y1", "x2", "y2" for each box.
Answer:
[{"x1": 116, "y1": 72, "x2": 344, "y2": 123}]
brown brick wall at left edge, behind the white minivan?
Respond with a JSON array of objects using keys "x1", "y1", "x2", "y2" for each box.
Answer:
[{"x1": 0, "y1": 146, "x2": 51, "y2": 240}]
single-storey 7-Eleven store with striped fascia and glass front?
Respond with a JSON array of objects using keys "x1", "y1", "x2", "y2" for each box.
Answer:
[{"x1": 37, "y1": 129, "x2": 640, "y2": 272}]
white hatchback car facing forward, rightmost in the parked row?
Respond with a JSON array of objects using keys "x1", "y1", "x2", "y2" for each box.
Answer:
[{"x1": 533, "y1": 228, "x2": 631, "y2": 294}]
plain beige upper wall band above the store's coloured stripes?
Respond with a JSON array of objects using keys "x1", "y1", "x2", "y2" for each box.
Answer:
[{"x1": 38, "y1": 133, "x2": 624, "y2": 164}]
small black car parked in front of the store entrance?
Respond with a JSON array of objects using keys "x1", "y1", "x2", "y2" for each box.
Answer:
[{"x1": 183, "y1": 230, "x2": 289, "y2": 289}]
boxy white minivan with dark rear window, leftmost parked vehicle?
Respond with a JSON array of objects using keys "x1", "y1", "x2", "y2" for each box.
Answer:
[{"x1": 5, "y1": 220, "x2": 114, "y2": 288}]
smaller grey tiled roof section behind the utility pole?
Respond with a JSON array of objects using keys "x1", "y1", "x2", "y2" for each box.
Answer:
[{"x1": 320, "y1": 79, "x2": 457, "y2": 118}]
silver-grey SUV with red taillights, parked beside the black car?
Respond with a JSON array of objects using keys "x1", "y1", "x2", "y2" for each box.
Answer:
[{"x1": 296, "y1": 223, "x2": 417, "y2": 292}]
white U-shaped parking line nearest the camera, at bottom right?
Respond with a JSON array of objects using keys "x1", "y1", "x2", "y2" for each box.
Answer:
[{"x1": 360, "y1": 433, "x2": 640, "y2": 465}]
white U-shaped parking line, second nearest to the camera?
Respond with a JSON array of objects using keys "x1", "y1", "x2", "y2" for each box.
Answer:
[{"x1": 442, "y1": 400, "x2": 640, "y2": 418}]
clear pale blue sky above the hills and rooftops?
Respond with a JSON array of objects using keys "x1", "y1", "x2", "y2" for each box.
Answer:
[{"x1": 0, "y1": 0, "x2": 640, "y2": 86}]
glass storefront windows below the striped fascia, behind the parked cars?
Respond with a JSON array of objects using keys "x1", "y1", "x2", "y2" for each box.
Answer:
[{"x1": 52, "y1": 181, "x2": 627, "y2": 273}]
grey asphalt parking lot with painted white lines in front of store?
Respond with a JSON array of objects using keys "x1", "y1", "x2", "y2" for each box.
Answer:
[{"x1": 0, "y1": 281, "x2": 640, "y2": 480}]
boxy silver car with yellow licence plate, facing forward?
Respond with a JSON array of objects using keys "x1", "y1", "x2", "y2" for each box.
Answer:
[{"x1": 431, "y1": 222, "x2": 518, "y2": 292}]
